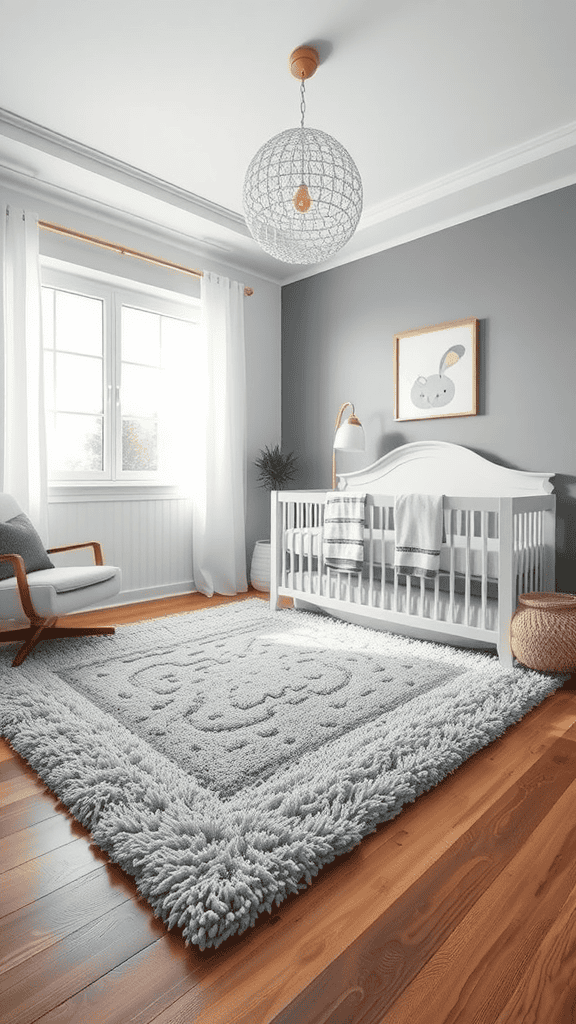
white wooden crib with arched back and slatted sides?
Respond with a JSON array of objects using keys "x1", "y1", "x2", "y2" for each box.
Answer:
[{"x1": 271, "y1": 441, "x2": 556, "y2": 668}]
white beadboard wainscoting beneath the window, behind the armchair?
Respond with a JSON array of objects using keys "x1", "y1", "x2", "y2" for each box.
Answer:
[{"x1": 48, "y1": 492, "x2": 195, "y2": 604}]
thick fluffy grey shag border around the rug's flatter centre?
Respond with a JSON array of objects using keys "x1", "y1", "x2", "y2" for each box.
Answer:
[{"x1": 0, "y1": 599, "x2": 567, "y2": 949}]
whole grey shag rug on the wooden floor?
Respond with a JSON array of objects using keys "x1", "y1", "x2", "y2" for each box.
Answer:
[{"x1": 0, "y1": 599, "x2": 567, "y2": 948}]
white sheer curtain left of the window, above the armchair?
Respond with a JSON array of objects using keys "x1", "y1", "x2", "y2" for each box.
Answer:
[{"x1": 0, "y1": 205, "x2": 48, "y2": 543}]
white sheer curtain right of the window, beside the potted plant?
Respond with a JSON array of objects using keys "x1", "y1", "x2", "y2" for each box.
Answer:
[{"x1": 191, "y1": 272, "x2": 248, "y2": 597}]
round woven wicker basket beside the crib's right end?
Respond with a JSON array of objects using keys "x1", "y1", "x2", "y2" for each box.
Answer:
[{"x1": 510, "y1": 594, "x2": 576, "y2": 672}]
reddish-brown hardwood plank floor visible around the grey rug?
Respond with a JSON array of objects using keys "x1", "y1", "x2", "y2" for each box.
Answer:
[{"x1": 0, "y1": 593, "x2": 576, "y2": 1024}]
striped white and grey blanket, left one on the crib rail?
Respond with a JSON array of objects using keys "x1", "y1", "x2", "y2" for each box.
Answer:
[{"x1": 322, "y1": 490, "x2": 366, "y2": 572}]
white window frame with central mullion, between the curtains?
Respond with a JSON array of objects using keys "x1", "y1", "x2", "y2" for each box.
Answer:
[{"x1": 41, "y1": 261, "x2": 201, "y2": 498}]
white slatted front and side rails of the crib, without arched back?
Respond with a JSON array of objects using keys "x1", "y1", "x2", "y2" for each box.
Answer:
[{"x1": 271, "y1": 490, "x2": 556, "y2": 640}]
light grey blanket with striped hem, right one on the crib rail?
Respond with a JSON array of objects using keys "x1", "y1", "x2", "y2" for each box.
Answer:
[{"x1": 394, "y1": 495, "x2": 443, "y2": 577}]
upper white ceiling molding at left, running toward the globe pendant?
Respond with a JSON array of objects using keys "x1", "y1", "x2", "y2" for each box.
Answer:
[{"x1": 0, "y1": 108, "x2": 250, "y2": 237}]
